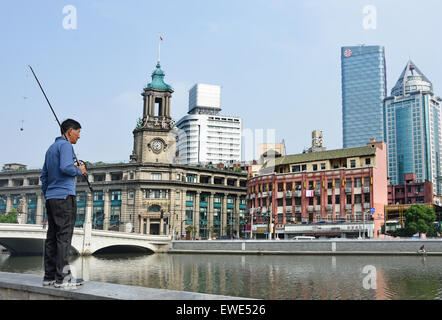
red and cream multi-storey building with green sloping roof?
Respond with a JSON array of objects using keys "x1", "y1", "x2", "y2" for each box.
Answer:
[{"x1": 247, "y1": 140, "x2": 387, "y2": 238}]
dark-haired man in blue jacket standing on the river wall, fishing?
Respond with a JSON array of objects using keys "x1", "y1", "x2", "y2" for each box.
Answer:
[{"x1": 40, "y1": 119, "x2": 86, "y2": 288}]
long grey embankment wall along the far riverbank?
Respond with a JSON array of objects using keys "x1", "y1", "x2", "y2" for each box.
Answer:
[{"x1": 167, "y1": 238, "x2": 442, "y2": 256}]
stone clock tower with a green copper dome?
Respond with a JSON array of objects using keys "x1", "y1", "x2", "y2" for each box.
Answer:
[{"x1": 130, "y1": 61, "x2": 176, "y2": 163}]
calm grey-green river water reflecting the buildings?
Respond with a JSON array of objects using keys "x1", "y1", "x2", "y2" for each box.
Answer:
[{"x1": 0, "y1": 253, "x2": 442, "y2": 300}]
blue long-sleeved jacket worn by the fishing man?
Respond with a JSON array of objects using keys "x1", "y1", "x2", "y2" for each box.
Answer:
[{"x1": 40, "y1": 137, "x2": 81, "y2": 200}]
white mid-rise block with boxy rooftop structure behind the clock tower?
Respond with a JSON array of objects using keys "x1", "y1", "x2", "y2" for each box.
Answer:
[{"x1": 176, "y1": 84, "x2": 242, "y2": 164}]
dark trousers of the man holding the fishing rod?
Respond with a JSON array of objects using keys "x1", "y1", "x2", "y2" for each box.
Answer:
[{"x1": 44, "y1": 196, "x2": 77, "y2": 282}]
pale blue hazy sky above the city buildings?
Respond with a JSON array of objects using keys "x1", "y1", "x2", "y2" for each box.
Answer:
[{"x1": 0, "y1": 0, "x2": 442, "y2": 168}]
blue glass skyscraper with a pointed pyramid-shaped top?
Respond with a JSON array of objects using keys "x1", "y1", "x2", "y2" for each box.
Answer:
[{"x1": 384, "y1": 61, "x2": 442, "y2": 195}]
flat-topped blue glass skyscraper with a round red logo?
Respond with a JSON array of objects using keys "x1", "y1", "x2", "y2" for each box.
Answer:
[{"x1": 341, "y1": 45, "x2": 387, "y2": 148}]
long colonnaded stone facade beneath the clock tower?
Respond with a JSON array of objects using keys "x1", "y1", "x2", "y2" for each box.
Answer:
[{"x1": 0, "y1": 163, "x2": 247, "y2": 238}]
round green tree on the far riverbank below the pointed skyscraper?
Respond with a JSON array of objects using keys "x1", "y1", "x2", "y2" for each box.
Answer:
[{"x1": 404, "y1": 204, "x2": 436, "y2": 237}]
